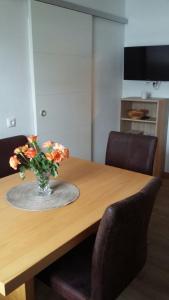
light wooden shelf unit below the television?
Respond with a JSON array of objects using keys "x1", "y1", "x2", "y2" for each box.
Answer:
[{"x1": 120, "y1": 97, "x2": 169, "y2": 176}]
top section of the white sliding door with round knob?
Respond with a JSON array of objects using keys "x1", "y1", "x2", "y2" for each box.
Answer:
[{"x1": 32, "y1": 1, "x2": 92, "y2": 56}]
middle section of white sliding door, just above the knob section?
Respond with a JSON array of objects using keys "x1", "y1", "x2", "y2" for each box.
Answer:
[{"x1": 34, "y1": 52, "x2": 91, "y2": 94}]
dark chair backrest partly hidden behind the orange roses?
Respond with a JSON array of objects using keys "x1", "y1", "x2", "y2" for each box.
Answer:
[{"x1": 0, "y1": 135, "x2": 27, "y2": 178}]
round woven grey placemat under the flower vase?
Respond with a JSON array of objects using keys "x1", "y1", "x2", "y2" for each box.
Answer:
[{"x1": 7, "y1": 180, "x2": 80, "y2": 211}]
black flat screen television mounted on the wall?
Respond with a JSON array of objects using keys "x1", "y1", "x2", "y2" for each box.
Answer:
[{"x1": 124, "y1": 45, "x2": 169, "y2": 81}]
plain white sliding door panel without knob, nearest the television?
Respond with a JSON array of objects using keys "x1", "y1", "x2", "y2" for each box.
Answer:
[{"x1": 93, "y1": 18, "x2": 124, "y2": 162}]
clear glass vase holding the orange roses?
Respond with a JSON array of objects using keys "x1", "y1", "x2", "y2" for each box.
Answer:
[{"x1": 36, "y1": 173, "x2": 52, "y2": 196}]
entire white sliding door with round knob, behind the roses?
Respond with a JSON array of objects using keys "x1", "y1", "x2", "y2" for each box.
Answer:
[{"x1": 32, "y1": 1, "x2": 92, "y2": 159}]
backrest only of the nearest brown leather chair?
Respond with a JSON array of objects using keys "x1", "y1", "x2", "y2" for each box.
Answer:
[{"x1": 91, "y1": 178, "x2": 160, "y2": 300}]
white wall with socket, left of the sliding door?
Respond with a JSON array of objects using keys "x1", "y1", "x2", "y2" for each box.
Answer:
[{"x1": 0, "y1": 0, "x2": 33, "y2": 138}]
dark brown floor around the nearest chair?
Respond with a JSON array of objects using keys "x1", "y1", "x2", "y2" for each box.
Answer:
[{"x1": 36, "y1": 179, "x2": 169, "y2": 300}]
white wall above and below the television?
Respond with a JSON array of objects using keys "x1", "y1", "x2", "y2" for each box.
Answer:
[{"x1": 123, "y1": 0, "x2": 169, "y2": 172}]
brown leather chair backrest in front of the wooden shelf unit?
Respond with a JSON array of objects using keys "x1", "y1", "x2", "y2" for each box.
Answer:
[{"x1": 106, "y1": 131, "x2": 157, "y2": 175}]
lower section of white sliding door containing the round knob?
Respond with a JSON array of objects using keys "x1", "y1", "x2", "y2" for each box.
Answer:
[{"x1": 37, "y1": 92, "x2": 91, "y2": 159}]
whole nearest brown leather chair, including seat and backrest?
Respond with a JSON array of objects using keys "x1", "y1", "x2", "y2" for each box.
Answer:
[{"x1": 39, "y1": 178, "x2": 160, "y2": 300}]
